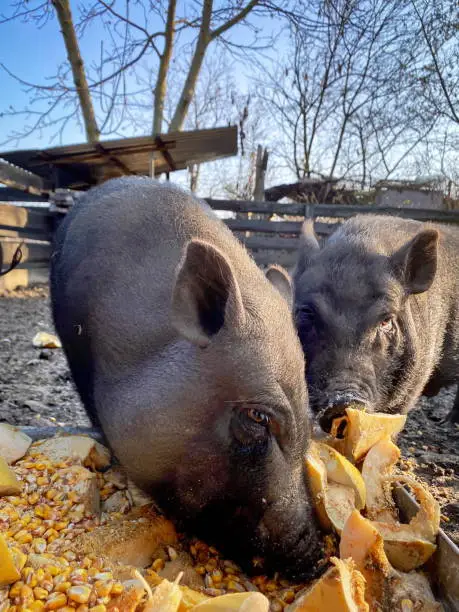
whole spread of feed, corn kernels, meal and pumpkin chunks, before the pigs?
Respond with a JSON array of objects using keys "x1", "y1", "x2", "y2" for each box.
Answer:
[{"x1": 0, "y1": 408, "x2": 441, "y2": 612}]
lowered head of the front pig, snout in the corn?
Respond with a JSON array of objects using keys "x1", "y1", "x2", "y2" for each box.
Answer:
[{"x1": 168, "y1": 240, "x2": 321, "y2": 577}]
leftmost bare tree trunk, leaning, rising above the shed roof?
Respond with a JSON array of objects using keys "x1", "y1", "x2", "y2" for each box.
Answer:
[{"x1": 52, "y1": 0, "x2": 100, "y2": 142}]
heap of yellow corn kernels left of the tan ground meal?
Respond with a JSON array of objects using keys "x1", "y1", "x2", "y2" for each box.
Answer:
[{"x1": 0, "y1": 452, "x2": 123, "y2": 612}]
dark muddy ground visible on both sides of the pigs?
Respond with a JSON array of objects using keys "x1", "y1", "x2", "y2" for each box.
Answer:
[{"x1": 0, "y1": 287, "x2": 459, "y2": 544}]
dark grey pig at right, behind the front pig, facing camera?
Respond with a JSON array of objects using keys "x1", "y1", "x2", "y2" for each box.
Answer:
[{"x1": 294, "y1": 215, "x2": 459, "y2": 430}]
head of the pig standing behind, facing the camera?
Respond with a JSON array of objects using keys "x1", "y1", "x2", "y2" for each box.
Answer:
[{"x1": 294, "y1": 220, "x2": 438, "y2": 431}]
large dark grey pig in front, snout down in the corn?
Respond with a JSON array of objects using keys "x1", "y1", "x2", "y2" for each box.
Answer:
[{"x1": 51, "y1": 177, "x2": 320, "y2": 577}]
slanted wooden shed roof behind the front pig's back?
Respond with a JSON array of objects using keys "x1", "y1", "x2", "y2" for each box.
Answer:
[{"x1": 0, "y1": 126, "x2": 237, "y2": 189}]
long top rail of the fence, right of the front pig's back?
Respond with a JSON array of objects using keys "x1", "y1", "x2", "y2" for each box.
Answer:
[{"x1": 206, "y1": 198, "x2": 459, "y2": 225}]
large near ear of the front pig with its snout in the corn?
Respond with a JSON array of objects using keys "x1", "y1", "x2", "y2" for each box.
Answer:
[{"x1": 172, "y1": 240, "x2": 245, "y2": 347}]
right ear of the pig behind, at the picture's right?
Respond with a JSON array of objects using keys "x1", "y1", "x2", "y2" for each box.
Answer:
[{"x1": 391, "y1": 229, "x2": 438, "y2": 293}]
